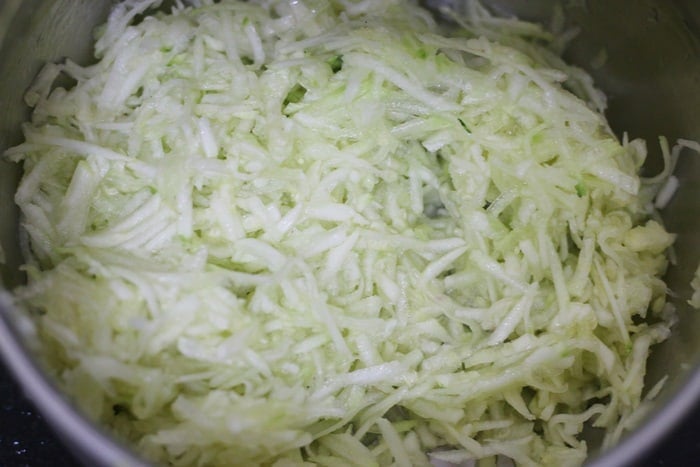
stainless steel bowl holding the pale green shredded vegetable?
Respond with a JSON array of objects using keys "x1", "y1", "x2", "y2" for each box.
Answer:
[{"x1": 0, "y1": 0, "x2": 700, "y2": 467}]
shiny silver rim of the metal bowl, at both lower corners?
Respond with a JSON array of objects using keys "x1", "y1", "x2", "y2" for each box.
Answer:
[{"x1": 0, "y1": 289, "x2": 700, "y2": 467}]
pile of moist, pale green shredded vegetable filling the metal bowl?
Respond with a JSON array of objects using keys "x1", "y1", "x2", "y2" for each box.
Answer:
[{"x1": 6, "y1": 0, "x2": 674, "y2": 467}]
